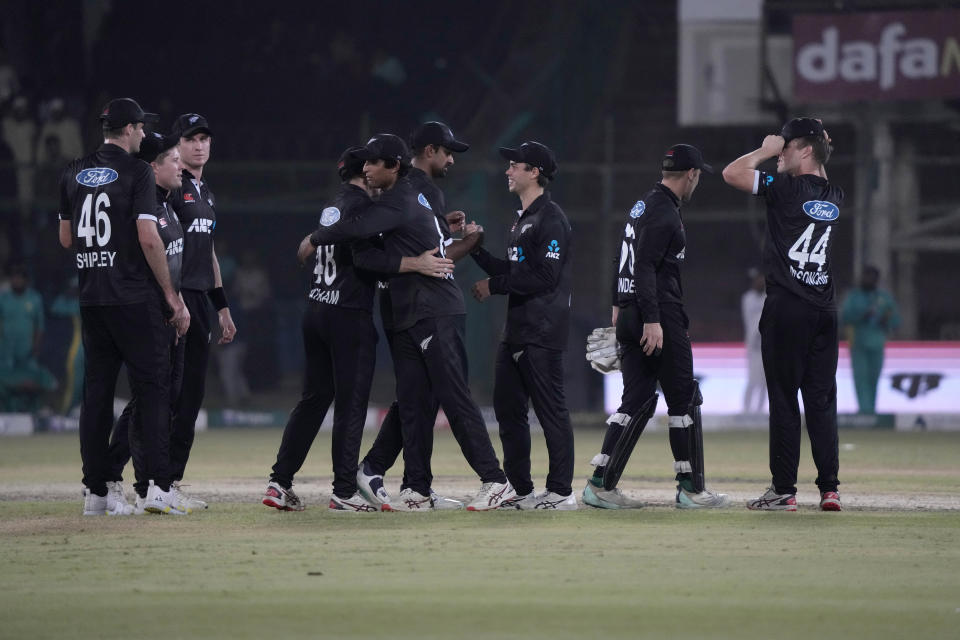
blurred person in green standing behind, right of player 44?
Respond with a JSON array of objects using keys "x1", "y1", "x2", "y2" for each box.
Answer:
[{"x1": 840, "y1": 265, "x2": 900, "y2": 415}]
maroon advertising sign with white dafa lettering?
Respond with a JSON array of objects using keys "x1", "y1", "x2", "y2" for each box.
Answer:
[{"x1": 793, "y1": 10, "x2": 960, "y2": 102}]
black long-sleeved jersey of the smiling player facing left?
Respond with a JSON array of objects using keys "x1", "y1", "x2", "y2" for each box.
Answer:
[{"x1": 472, "y1": 192, "x2": 573, "y2": 349}]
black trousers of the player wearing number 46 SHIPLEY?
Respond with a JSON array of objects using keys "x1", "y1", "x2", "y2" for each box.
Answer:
[{"x1": 80, "y1": 297, "x2": 172, "y2": 495}]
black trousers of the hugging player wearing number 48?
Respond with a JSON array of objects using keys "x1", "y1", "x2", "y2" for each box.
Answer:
[{"x1": 270, "y1": 302, "x2": 378, "y2": 498}]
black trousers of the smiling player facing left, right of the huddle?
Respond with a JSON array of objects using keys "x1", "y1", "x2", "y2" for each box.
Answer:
[{"x1": 493, "y1": 343, "x2": 574, "y2": 496}]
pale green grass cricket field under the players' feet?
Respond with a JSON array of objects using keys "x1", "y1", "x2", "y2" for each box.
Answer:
[{"x1": 0, "y1": 430, "x2": 960, "y2": 640}]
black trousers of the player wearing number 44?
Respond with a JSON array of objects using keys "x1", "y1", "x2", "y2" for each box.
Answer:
[{"x1": 760, "y1": 290, "x2": 840, "y2": 494}]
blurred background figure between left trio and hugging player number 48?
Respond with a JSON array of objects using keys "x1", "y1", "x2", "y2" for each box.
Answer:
[{"x1": 233, "y1": 249, "x2": 278, "y2": 391}]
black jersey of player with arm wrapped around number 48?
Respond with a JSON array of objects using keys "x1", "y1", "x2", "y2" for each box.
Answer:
[{"x1": 313, "y1": 178, "x2": 466, "y2": 331}]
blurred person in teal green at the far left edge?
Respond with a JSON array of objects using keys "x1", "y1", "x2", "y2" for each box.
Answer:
[{"x1": 0, "y1": 265, "x2": 57, "y2": 412}]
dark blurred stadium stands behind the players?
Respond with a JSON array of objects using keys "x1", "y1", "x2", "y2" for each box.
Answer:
[{"x1": 0, "y1": 0, "x2": 960, "y2": 411}]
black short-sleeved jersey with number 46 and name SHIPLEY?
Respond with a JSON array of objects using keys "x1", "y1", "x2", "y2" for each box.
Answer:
[{"x1": 59, "y1": 144, "x2": 160, "y2": 306}]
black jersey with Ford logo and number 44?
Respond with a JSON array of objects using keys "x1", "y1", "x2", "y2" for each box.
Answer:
[{"x1": 753, "y1": 171, "x2": 843, "y2": 309}]
